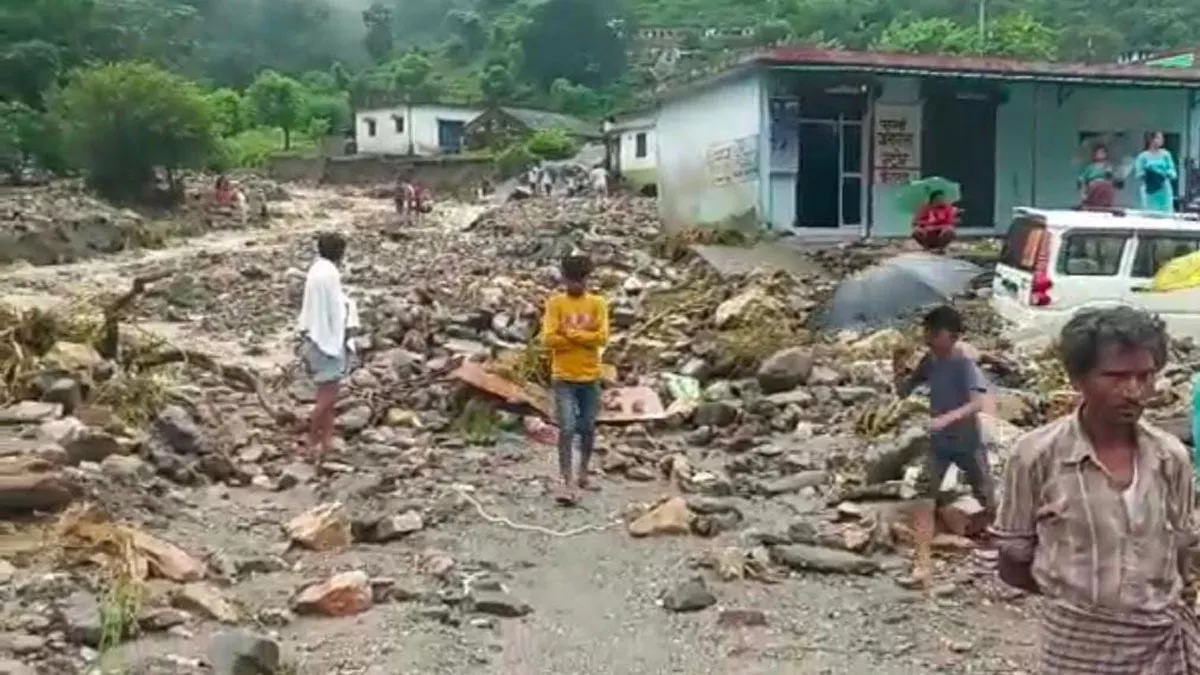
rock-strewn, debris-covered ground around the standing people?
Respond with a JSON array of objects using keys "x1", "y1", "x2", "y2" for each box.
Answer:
[{"x1": 0, "y1": 181, "x2": 1193, "y2": 675}]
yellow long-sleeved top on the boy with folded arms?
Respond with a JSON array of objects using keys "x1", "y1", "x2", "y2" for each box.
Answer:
[{"x1": 541, "y1": 292, "x2": 608, "y2": 382}]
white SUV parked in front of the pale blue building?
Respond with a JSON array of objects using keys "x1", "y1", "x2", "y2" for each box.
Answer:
[{"x1": 992, "y1": 208, "x2": 1200, "y2": 340}]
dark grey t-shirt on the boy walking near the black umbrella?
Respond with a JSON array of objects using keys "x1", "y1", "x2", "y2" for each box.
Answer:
[{"x1": 898, "y1": 351, "x2": 988, "y2": 455}]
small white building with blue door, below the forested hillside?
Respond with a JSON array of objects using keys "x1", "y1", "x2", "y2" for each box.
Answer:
[{"x1": 354, "y1": 103, "x2": 484, "y2": 156}]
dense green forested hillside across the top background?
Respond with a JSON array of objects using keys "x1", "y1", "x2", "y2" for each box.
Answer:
[{"x1": 0, "y1": 0, "x2": 1200, "y2": 195}]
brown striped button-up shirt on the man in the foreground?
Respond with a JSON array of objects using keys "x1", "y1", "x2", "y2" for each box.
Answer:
[{"x1": 992, "y1": 413, "x2": 1195, "y2": 613}]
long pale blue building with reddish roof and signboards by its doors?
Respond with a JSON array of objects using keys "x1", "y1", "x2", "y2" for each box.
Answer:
[{"x1": 654, "y1": 48, "x2": 1200, "y2": 239}]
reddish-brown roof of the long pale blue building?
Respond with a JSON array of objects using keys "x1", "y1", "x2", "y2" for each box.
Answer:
[{"x1": 748, "y1": 47, "x2": 1200, "y2": 89}]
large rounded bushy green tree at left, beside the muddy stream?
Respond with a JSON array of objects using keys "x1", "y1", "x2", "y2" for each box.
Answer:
[{"x1": 53, "y1": 62, "x2": 216, "y2": 198}]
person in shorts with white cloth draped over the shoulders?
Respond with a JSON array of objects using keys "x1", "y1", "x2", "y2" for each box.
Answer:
[{"x1": 296, "y1": 232, "x2": 358, "y2": 465}]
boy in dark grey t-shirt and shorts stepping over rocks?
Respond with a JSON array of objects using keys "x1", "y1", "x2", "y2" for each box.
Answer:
[{"x1": 896, "y1": 306, "x2": 996, "y2": 578}]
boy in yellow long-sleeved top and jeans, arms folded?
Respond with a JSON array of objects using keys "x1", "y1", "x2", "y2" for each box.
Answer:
[{"x1": 541, "y1": 253, "x2": 608, "y2": 503}]
